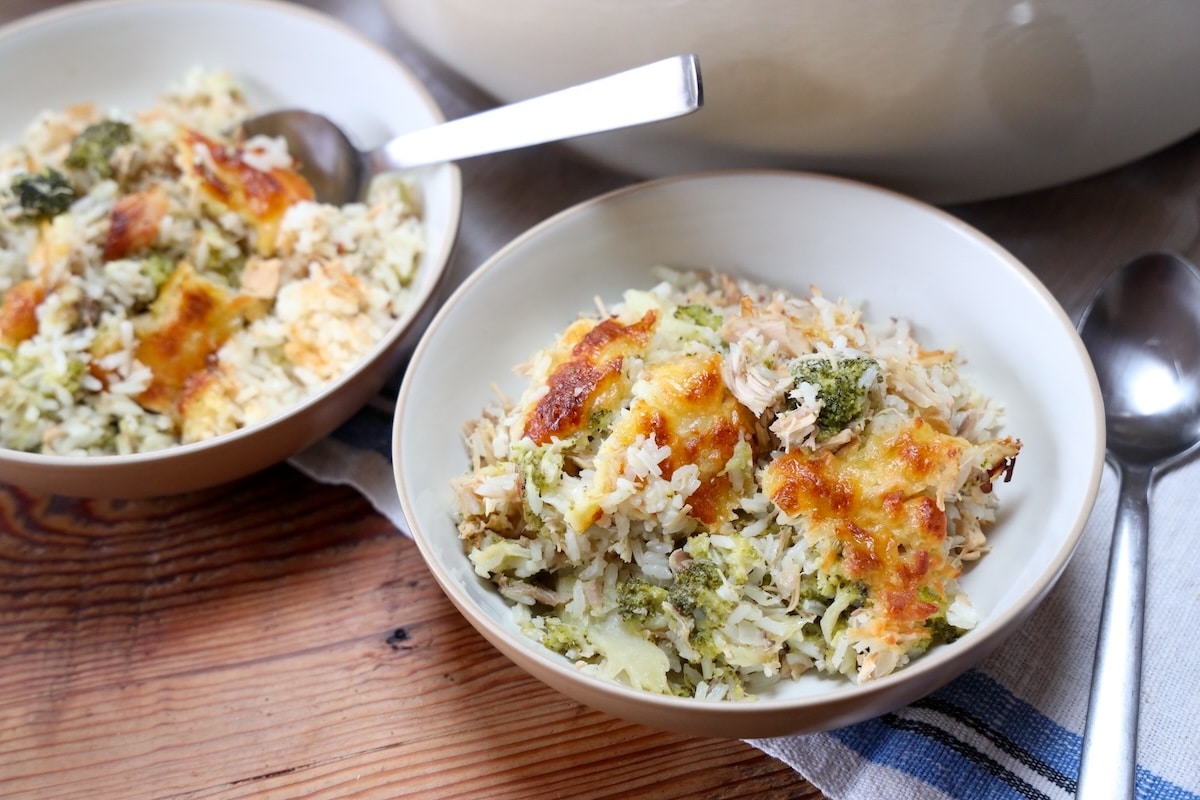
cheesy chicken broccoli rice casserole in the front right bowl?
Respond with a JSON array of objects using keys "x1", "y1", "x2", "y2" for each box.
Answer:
[{"x1": 454, "y1": 270, "x2": 1021, "y2": 699}]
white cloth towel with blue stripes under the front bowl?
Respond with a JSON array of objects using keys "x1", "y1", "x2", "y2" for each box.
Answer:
[{"x1": 292, "y1": 395, "x2": 1200, "y2": 800}]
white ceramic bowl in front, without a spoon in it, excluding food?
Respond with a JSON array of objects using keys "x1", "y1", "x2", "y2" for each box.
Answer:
[{"x1": 392, "y1": 172, "x2": 1104, "y2": 738}]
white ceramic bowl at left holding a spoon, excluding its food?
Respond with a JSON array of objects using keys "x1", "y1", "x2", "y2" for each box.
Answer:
[{"x1": 0, "y1": 0, "x2": 462, "y2": 497}]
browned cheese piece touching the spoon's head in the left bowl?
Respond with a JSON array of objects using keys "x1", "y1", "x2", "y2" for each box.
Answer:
[{"x1": 179, "y1": 130, "x2": 313, "y2": 255}]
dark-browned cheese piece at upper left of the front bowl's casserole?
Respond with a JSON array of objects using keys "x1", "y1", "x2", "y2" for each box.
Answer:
[{"x1": 524, "y1": 311, "x2": 658, "y2": 445}]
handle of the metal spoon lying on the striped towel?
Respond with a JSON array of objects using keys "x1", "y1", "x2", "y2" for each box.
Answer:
[{"x1": 1075, "y1": 465, "x2": 1152, "y2": 800}]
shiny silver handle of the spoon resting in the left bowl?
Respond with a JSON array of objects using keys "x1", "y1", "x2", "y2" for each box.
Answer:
[{"x1": 367, "y1": 54, "x2": 703, "y2": 174}]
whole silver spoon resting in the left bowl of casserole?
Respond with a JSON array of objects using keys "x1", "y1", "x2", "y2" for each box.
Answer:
[{"x1": 242, "y1": 54, "x2": 703, "y2": 205}]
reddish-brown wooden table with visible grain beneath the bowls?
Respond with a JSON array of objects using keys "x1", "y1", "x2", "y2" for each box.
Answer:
[{"x1": 7, "y1": 0, "x2": 1200, "y2": 800}]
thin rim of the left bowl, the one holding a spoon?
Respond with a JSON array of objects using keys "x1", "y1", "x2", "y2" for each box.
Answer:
[{"x1": 0, "y1": 0, "x2": 463, "y2": 469}]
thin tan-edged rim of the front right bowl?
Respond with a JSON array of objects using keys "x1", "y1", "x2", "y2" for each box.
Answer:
[{"x1": 392, "y1": 168, "x2": 1105, "y2": 716}]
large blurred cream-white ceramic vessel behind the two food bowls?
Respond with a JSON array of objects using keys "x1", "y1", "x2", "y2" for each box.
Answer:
[{"x1": 383, "y1": 0, "x2": 1200, "y2": 203}]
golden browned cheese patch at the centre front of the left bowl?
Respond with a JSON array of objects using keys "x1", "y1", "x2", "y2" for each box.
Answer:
[{"x1": 137, "y1": 261, "x2": 257, "y2": 414}]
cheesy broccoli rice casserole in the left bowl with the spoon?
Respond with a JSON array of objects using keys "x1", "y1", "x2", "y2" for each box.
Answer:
[{"x1": 0, "y1": 70, "x2": 424, "y2": 455}]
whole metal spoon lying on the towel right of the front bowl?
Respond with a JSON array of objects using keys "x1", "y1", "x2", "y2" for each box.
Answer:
[{"x1": 1076, "y1": 253, "x2": 1200, "y2": 800}]
